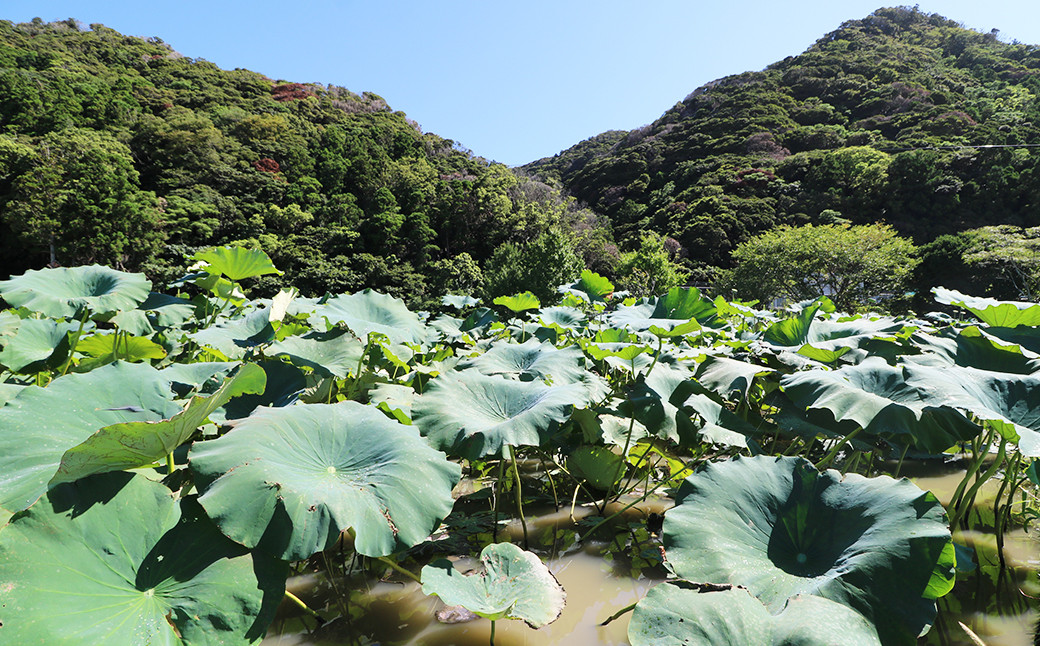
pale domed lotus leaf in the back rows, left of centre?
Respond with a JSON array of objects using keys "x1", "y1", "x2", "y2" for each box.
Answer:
[{"x1": 308, "y1": 289, "x2": 428, "y2": 343}]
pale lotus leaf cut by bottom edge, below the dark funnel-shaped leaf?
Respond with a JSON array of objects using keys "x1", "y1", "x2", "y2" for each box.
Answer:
[{"x1": 628, "y1": 582, "x2": 881, "y2": 646}]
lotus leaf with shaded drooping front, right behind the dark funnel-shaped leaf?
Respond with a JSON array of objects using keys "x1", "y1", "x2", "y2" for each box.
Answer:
[{"x1": 780, "y1": 357, "x2": 980, "y2": 453}]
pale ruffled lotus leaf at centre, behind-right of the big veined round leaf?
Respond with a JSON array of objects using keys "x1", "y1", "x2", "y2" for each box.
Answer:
[{"x1": 412, "y1": 370, "x2": 588, "y2": 460}]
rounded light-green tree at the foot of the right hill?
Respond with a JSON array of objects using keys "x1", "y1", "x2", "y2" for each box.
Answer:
[{"x1": 719, "y1": 224, "x2": 917, "y2": 310}]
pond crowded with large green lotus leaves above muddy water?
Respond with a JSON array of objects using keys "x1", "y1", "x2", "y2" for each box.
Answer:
[{"x1": 0, "y1": 248, "x2": 1040, "y2": 646}]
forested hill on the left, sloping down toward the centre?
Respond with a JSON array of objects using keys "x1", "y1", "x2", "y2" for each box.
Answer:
[{"x1": 0, "y1": 20, "x2": 609, "y2": 305}]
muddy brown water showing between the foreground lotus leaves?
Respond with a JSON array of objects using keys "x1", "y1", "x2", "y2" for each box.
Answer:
[{"x1": 262, "y1": 464, "x2": 1040, "y2": 646}]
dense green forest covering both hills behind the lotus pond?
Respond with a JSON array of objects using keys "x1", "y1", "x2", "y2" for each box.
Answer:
[{"x1": 0, "y1": 7, "x2": 1040, "y2": 307}]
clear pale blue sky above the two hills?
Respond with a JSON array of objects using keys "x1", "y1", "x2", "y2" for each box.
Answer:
[{"x1": 0, "y1": 0, "x2": 1040, "y2": 165}]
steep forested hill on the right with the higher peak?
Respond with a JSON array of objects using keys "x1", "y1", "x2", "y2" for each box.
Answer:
[{"x1": 524, "y1": 7, "x2": 1040, "y2": 276}]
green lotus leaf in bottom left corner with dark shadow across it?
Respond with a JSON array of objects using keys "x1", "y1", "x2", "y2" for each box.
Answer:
[{"x1": 0, "y1": 473, "x2": 287, "y2": 646}]
